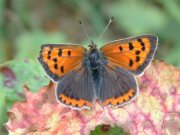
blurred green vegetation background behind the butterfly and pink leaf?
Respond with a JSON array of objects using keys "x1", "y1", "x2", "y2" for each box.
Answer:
[{"x1": 0, "y1": 0, "x2": 180, "y2": 134}]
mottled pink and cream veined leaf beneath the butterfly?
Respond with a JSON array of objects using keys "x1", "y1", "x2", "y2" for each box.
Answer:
[{"x1": 6, "y1": 61, "x2": 180, "y2": 135}]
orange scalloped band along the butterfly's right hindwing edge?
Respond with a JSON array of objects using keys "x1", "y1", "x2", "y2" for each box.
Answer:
[{"x1": 103, "y1": 89, "x2": 134, "y2": 106}]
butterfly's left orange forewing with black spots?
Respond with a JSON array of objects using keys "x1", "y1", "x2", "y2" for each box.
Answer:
[{"x1": 39, "y1": 44, "x2": 86, "y2": 78}]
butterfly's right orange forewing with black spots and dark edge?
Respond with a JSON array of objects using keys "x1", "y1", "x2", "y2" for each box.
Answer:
[{"x1": 101, "y1": 35, "x2": 157, "y2": 74}]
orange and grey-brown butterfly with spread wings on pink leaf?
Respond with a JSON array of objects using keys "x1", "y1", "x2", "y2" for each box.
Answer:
[{"x1": 38, "y1": 35, "x2": 158, "y2": 109}]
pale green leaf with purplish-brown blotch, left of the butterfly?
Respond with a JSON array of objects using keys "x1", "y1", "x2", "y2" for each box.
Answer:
[{"x1": 0, "y1": 60, "x2": 49, "y2": 104}]
